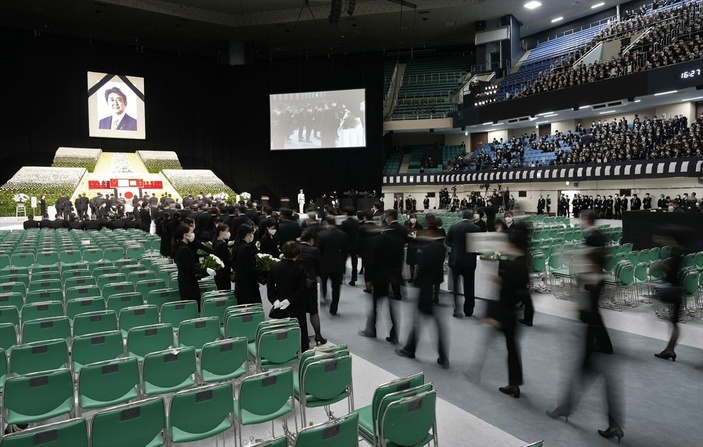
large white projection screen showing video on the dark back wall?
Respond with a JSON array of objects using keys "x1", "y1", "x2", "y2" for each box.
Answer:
[{"x1": 269, "y1": 89, "x2": 366, "y2": 150}]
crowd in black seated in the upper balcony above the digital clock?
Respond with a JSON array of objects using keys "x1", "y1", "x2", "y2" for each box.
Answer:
[{"x1": 506, "y1": 2, "x2": 703, "y2": 99}]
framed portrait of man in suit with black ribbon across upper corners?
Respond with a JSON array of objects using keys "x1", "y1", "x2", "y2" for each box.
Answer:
[{"x1": 88, "y1": 71, "x2": 146, "y2": 140}]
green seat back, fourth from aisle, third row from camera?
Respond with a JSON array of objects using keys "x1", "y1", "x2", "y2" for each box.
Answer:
[{"x1": 78, "y1": 357, "x2": 139, "y2": 409}]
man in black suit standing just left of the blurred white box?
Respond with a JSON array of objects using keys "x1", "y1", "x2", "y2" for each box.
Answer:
[{"x1": 445, "y1": 210, "x2": 481, "y2": 318}]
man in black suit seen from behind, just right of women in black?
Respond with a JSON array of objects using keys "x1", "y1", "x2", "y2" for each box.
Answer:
[{"x1": 317, "y1": 216, "x2": 349, "y2": 315}]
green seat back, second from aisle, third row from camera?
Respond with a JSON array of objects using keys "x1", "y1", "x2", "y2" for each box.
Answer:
[{"x1": 200, "y1": 337, "x2": 248, "y2": 383}]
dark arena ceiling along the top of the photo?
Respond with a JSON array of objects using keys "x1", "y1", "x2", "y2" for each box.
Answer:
[{"x1": 0, "y1": 0, "x2": 622, "y2": 58}]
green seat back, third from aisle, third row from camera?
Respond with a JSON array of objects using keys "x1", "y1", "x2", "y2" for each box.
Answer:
[{"x1": 142, "y1": 346, "x2": 196, "y2": 396}]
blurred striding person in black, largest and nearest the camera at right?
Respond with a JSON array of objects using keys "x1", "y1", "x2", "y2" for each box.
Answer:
[{"x1": 547, "y1": 210, "x2": 625, "y2": 443}]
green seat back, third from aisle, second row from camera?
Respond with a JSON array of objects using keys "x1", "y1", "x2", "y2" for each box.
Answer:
[{"x1": 169, "y1": 382, "x2": 233, "y2": 442}]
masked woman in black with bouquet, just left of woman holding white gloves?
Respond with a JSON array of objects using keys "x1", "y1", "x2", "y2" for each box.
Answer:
[{"x1": 232, "y1": 224, "x2": 261, "y2": 304}]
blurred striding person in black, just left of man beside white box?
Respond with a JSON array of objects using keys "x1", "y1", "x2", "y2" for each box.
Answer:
[{"x1": 395, "y1": 230, "x2": 449, "y2": 369}]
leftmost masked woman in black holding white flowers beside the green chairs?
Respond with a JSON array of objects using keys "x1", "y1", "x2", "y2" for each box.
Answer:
[{"x1": 173, "y1": 223, "x2": 215, "y2": 307}]
